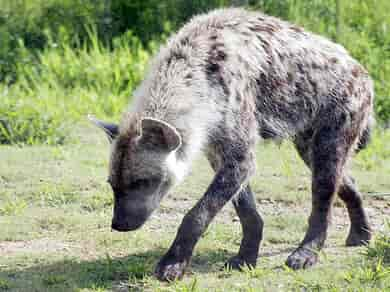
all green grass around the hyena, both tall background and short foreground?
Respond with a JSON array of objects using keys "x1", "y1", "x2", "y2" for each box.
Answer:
[{"x1": 0, "y1": 0, "x2": 390, "y2": 292}]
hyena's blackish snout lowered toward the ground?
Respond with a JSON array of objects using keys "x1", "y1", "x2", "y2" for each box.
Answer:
[{"x1": 111, "y1": 199, "x2": 153, "y2": 232}]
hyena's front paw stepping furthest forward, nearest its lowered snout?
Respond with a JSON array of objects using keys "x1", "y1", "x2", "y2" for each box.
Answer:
[{"x1": 154, "y1": 256, "x2": 189, "y2": 282}]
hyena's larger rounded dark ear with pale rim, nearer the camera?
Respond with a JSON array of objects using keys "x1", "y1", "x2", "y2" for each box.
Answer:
[{"x1": 141, "y1": 118, "x2": 181, "y2": 152}]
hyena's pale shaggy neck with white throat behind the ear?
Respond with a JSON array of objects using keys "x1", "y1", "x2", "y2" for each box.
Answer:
[{"x1": 127, "y1": 48, "x2": 221, "y2": 181}]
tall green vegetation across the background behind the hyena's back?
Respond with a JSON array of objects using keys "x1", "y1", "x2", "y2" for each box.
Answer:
[{"x1": 0, "y1": 0, "x2": 390, "y2": 144}]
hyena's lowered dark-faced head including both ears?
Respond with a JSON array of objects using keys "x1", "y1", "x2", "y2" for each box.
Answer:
[{"x1": 91, "y1": 118, "x2": 181, "y2": 231}]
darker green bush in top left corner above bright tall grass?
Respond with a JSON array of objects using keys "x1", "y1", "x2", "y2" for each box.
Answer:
[{"x1": 0, "y1": 0, "x2": 104, "y2": 82}]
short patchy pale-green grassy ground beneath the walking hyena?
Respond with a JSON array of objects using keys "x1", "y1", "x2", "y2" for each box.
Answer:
[{"x1": 0, "y1": 125, "x2": 390, "y2": 291}]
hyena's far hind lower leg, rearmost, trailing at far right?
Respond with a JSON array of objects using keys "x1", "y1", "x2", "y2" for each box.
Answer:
[{"x1": 338, "y1": 175, "x2": 372, "y2": 246}]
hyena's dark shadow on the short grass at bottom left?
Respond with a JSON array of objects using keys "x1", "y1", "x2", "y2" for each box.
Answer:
[{"x1": 0, "y1": 248, "x2": 232, "y2": 291}]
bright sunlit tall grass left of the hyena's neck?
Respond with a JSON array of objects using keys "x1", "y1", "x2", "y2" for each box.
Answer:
[{"x1": 0, "y1": 29, "x2": 149, "y2": 144}]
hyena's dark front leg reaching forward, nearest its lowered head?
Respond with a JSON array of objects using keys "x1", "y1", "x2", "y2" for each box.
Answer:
[{"x1": 155, "y1": 141, "x2": 254, "y2": 281}]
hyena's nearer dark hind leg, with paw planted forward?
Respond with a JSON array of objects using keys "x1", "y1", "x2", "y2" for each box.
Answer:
[{"x1": 286, "y1": 122, "x2": 356, "y2": 269}]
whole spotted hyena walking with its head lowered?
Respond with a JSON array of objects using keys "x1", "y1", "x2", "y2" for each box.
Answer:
[{"x1": 89, "y1": 9, "x2": 374, "y2": 280}]
